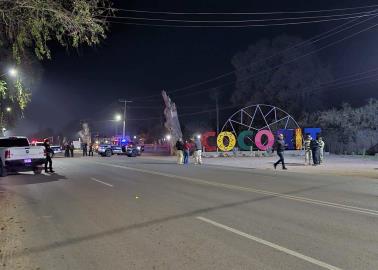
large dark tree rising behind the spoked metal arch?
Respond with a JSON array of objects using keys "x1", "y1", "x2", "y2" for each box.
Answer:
[{"x1": 231, "y1": 35, "x2": 332, "y2": 116}]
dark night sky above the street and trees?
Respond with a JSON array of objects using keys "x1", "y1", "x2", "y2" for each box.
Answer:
[{"x1": 13, "y1": 0, "x2": 378, "y2": 137}]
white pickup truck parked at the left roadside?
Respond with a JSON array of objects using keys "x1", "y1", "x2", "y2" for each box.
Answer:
[{"x1": 0, "y1": 137, "x2": 46, "y2": 177}]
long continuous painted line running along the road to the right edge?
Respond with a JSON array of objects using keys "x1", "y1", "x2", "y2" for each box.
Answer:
[{"x1": 93, "y1": 162, "x2": 378, "y2": 216}]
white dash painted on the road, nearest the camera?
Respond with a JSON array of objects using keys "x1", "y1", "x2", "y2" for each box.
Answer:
[{"x1": 197, "y1": 217, "x2": 341, "y2": 270}]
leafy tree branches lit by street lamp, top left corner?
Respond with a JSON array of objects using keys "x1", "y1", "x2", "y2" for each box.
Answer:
[{"x1": 0, "y1": 0, "x2": 112, "y2": 131}]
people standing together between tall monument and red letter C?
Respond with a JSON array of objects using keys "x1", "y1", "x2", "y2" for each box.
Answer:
[{"x1": 176, "y1": 137, "x2": 202, "y2": 165}]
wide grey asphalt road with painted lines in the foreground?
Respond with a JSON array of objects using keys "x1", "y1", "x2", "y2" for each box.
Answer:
[{"x1": 0, "y1": 156, "x2": 378, "y2": 270}]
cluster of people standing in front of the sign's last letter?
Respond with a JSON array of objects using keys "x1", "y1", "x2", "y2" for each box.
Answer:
[{"x1": 304, "y1": 134, "x2": 325, "y2": 166}]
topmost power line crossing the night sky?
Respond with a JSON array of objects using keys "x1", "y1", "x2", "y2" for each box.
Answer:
[{"x1": 114, "y1": 5, "x2": 378, "y2": 15}]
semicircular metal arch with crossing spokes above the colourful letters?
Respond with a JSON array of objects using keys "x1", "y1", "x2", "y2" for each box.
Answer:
[{"x1": 222, "y1": 104, "x2": 300, "y2": 136}]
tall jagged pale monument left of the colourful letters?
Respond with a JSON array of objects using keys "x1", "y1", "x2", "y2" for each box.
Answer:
[{"x1": 162, "y1": 91, "x2": 182, "y2": 154}]
